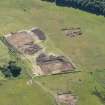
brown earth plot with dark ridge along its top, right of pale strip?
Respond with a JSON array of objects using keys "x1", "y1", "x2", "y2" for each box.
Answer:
[{"x1": 36, "y1": 54, "x2": 74, "y2": 75}]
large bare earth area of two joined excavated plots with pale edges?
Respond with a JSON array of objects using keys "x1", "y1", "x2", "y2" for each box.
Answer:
[{"x1": 5, "y1": 28, "x2": 75, "y2": 76}]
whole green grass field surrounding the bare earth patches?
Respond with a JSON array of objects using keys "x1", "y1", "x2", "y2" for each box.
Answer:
[{"x1": 0, "y1": 0, "x2": 105, "y2": 105}]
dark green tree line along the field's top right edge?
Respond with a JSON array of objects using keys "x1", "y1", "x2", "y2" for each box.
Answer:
[{"x1": 43, "y1": 0, "x2": 105, "y2": 16}]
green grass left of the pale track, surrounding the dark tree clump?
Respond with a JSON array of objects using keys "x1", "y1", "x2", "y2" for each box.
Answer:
[{"x1": 0, "y1": 41, "x2": 55, "y2": 105}]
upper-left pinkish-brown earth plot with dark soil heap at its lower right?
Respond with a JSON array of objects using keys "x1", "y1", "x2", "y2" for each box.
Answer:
[{"x1": 6, "y1": 31, "x2": 41, "y2": 55}]
